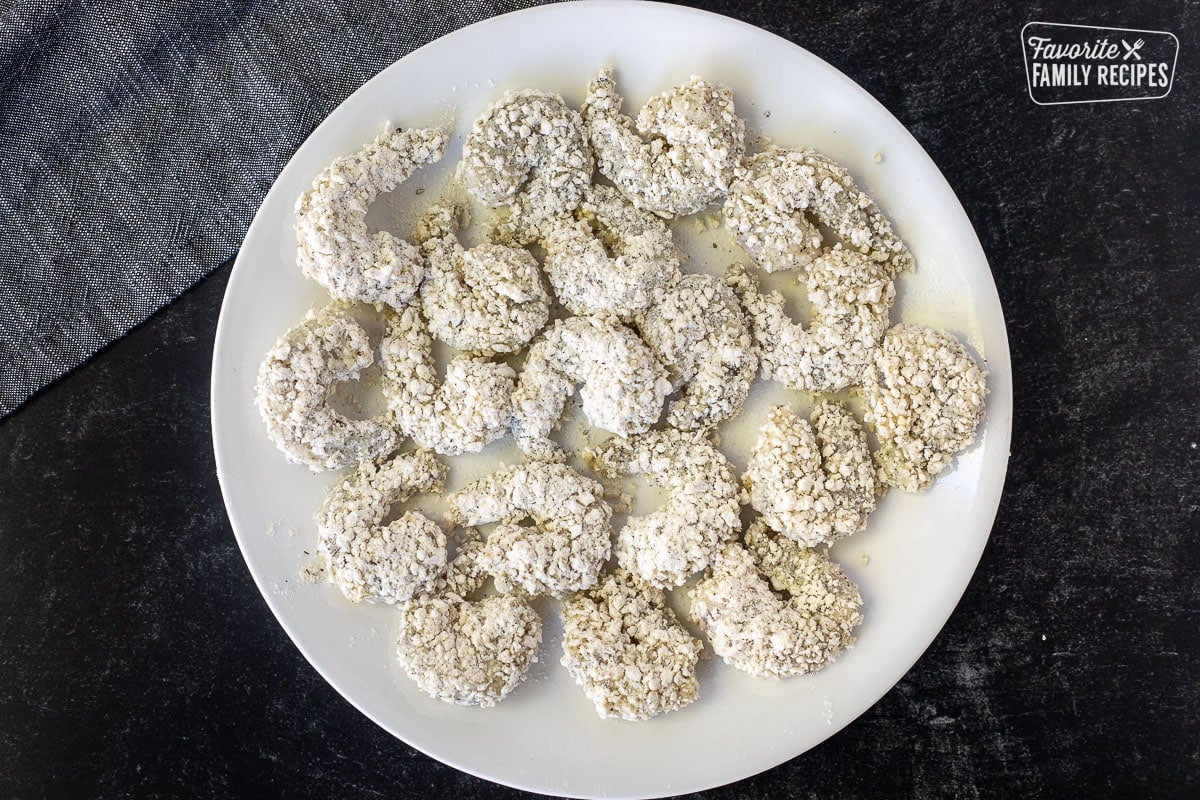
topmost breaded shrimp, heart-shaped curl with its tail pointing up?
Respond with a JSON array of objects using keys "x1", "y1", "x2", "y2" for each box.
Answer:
[{"x1": 583, "y1": 68, "x2": 745, "y2": 217}]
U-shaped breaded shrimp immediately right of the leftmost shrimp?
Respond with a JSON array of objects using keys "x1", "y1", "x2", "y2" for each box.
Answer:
[{"x1": 379, "y1": 306, "x2": 516, "y2": 456}]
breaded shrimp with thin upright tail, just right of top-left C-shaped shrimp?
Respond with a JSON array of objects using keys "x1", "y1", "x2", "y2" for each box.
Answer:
[{"x1": 415, "y1": 204, "x2": 550, "y2": 355}]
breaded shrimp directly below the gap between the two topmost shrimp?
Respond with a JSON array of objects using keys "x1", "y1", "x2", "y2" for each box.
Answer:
[{"x1": 541, "y1": 186, "x2": 683, "y2": 319}]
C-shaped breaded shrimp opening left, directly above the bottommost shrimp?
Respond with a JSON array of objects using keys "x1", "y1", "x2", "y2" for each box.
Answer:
[{"x1": 583, "y1": 428, "x2": 742, "y2": 589}]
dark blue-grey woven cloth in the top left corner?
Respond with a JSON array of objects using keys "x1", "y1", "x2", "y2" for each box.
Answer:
[{"x1": 0, "y1": 0, "x2": 549, "y2": 417}]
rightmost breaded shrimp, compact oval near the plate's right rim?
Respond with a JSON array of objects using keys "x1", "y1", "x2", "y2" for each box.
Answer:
[{"x1": 863, "y1": 324, "x2": 988, "y2": 492}]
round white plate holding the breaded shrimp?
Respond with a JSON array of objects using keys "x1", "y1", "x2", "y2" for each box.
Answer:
[{"x1": 212, "y1": 2, "x2": 1012, "y2": 796}]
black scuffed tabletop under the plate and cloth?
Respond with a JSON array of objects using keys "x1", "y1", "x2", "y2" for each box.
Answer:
[{"x1": 0, "y1": 1, "x2": 1200, "y2": 799}]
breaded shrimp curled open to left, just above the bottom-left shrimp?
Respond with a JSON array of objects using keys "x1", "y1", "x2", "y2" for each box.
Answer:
[{"x1": 445, "y1": 462, "x2": 612, "y2": 597}]
